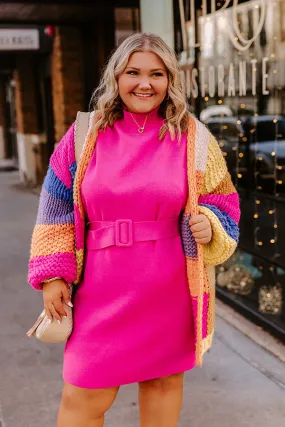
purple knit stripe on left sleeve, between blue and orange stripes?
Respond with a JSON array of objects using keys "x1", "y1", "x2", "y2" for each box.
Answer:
[{"x1": 37, "y1": 188, "x2": 74, "y2": 224}]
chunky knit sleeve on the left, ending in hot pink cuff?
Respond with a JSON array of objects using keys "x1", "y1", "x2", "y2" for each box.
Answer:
[{"x1": 28, "y1": 124, "x2": 76, "y2": 290}]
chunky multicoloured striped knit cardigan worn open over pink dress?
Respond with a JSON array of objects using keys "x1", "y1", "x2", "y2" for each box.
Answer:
[{"x1": 28, "y1": 115, "x2": 240, "y2": 366}]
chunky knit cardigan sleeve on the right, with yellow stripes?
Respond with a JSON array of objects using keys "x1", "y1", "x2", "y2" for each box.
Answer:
[{"x1": 198, "y1": 135, "x2": 240, "y2": 265}]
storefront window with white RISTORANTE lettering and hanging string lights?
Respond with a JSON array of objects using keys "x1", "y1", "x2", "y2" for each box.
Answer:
[{"x1": 173, "y1": 0, "x2": 285, "y2": 338}]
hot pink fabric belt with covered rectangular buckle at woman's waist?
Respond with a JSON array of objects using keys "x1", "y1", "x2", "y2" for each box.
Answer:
[{"x1": 86, "y1": 218, "x2": 179, "y2": 250}]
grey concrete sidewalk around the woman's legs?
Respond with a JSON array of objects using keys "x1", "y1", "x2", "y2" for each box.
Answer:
[{"x1": 0, "y1": 172, "x2": 285, "y2": 427}]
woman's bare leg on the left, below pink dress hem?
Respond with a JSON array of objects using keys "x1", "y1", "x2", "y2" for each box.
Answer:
[{"x1": 57, "y1": 383, "x2": 119, "y2": 427}]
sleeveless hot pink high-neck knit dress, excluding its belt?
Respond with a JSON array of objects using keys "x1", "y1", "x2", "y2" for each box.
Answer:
[{"x1": 63, "y1": 110, "x2": 195, "y2": 388}]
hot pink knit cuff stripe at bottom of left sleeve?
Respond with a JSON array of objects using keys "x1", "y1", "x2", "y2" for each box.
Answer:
[{"x1": 28, "y1": 253, "x2": 76, "y2": 289}]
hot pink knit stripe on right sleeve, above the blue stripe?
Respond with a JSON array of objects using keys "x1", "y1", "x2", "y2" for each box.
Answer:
[{"x1": 198, "y1": 192, "x2": 240, "y2": 224}]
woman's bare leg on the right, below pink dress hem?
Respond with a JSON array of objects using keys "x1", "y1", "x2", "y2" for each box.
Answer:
[{"x1": 139, "y1": 372, "x2": 184, "y2": 427}]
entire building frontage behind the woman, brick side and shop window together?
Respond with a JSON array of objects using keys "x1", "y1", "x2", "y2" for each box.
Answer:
[{"x1": 0, "y1": 0, "x2": 285, "y2": 341}]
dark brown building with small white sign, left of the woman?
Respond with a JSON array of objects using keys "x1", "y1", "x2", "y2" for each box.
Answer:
[{"x1": 0, "y1": 0, "x2": 140, "y2": 186}]
